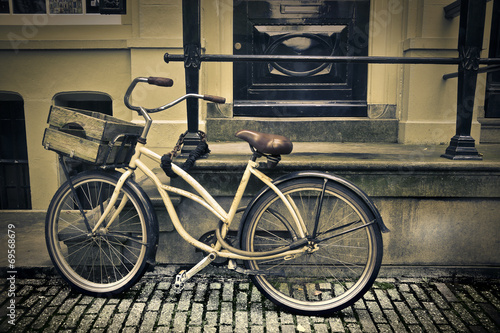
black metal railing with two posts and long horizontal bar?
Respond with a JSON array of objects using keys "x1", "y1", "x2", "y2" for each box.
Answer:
[{"x1": 171, "y1": 0, "x2": 500, "y2": 160}]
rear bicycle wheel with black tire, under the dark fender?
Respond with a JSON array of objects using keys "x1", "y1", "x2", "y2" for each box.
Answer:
[{"x1": 241, "y1": 178, "x2": 383, "y2": 316}]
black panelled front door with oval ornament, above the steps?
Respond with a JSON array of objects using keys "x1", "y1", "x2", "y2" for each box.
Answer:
[{"x1": 233, "y1": 0, "x2": 370, "y2": 117}]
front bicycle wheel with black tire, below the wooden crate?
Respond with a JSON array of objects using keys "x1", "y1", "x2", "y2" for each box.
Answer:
[{"x1": 45, "y1": 171, "x2": 158, "y2": 296}]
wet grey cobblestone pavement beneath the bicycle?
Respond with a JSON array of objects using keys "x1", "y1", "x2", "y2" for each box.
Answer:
[{"x1": 0, "y1": 267, "x2": 500, "y2": 332}]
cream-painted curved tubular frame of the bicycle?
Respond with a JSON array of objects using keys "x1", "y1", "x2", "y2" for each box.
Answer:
[{"x1": 92, "y1": 139, "x2": 307, "y2": 261}]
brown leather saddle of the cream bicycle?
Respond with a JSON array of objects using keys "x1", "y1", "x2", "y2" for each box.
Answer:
[{"x1": 236, "y1": 130, "x2": 293, "y2": 155}]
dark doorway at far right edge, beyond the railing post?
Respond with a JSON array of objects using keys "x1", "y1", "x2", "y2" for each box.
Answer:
[{"x1": 484, "y1": 0, "x2": 500, "y2": 118}]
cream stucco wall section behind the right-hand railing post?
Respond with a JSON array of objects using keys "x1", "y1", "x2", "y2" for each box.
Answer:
[{"x1": 398, "y1": 0, "x2": 492, "y2": 143}]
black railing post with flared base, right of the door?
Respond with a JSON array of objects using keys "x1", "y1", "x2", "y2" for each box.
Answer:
[{"x1": 441, "y1": 0, "x2": 486, "y2": 160}]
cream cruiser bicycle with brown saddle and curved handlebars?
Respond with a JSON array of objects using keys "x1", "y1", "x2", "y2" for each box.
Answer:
[{"x1": 45, "y1": 77, "x2": 388, "y2": 315}]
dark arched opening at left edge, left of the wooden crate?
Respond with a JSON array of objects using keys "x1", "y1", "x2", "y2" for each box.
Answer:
[{"x1": 0, "y1": 93, "x2": 31, "y2": 209}]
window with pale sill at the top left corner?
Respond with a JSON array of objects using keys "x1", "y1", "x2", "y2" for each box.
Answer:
[{"x1": 0, "y1": 0, "x2": 126, "y2": 25}]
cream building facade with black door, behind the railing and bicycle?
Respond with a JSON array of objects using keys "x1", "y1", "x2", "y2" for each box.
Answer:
[{"x1": 0, "y1": 0, "x2": 500, "y2": 210}]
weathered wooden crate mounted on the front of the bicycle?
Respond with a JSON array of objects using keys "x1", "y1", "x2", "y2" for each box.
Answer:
[{"x1": 42, "y1": 106, "x2": 143, "y2": 165}]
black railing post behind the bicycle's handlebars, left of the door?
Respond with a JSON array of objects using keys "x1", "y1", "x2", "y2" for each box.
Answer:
[{"x1": 181, "y1": 0, "x2": 201, "y2": 154}]
